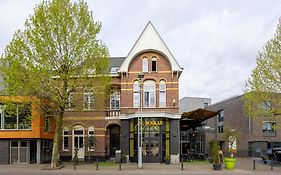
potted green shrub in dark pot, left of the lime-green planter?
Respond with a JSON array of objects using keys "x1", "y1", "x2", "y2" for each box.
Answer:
[{"x1": 209, "y1": 140, "x2": 221, "y2": 170}]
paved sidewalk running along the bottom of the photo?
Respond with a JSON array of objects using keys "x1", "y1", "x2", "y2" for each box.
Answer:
[{"x1": 0, "y1": 159, "x2": 281, "y2": 175}]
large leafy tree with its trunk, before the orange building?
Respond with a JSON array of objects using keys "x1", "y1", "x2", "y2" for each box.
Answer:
[{"x1": 0, "y1": 0, "x2": 110, "y2": 167}]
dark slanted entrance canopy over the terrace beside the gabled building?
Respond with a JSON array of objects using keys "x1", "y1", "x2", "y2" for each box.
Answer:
[{"x1": 181, "y1": 108, "x2": 218, "y2": 130}]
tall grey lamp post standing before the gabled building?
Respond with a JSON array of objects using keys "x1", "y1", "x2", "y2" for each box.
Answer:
[{"x1": 138, "y1": 73, "x2": 144, "y2": 168}]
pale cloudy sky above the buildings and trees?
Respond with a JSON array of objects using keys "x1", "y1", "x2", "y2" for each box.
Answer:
[{"x1": 0, "y1": 0, "x2": 281, "y2": 103}]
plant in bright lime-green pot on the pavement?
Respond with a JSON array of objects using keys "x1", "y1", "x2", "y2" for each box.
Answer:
[{"x1": 224, "y1": 129, "x2": 239, "y2": 169}]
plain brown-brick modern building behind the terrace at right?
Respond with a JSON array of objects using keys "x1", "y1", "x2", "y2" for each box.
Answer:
[{"x1": 203, "y1": 96, "x2": 281, "y2": 156}]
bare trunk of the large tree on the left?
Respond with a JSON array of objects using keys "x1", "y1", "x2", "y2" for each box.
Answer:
[{"x1": 51, "y1": 111, "x2": 63, "y2": 168}]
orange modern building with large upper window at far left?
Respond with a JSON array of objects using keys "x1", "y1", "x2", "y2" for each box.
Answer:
[{"x1": 0, "y1": 96, "x2": 55, "y2": 164}]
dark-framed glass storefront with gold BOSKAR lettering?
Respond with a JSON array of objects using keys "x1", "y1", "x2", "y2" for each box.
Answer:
[{"x1": 130, "y1": 118, "x2": 170, "y2": 163}]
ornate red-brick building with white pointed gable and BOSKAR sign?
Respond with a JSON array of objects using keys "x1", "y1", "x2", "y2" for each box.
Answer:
[{"x1": 60, "y1": 22, "x2": 183, "y2": 162}]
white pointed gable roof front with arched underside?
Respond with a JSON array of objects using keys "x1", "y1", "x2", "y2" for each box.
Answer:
[{"x1": 119, "y1": 21, "x2": 182, "y2": 72}]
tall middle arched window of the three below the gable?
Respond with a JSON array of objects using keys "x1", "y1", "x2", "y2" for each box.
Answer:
[{"x1": 143, "y1": 80, "x2": 156, "y2": 107}]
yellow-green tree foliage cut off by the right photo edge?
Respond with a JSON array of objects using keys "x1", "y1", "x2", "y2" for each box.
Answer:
[{"x1": 244, "y1": 19, "x2": 281, "y2": 119}]
